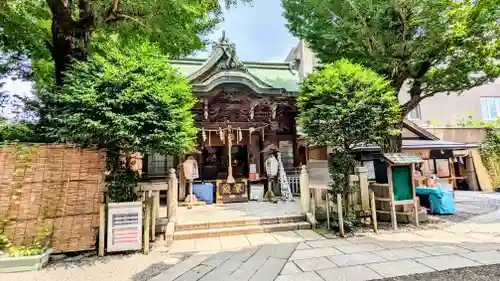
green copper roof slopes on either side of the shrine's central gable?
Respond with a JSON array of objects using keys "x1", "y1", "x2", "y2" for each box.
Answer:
[{"x1": 169, "y1": 58, "x2": 300, "y2": 92}]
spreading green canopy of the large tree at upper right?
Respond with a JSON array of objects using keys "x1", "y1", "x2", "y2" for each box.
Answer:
[{"x1": 282, "y1": 0, "x2": 500, "y2": 117}]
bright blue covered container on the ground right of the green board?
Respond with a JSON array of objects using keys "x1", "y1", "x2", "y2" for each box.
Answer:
[{"x1": 416, "y1": 188, "x2": 456, "y2": 215}]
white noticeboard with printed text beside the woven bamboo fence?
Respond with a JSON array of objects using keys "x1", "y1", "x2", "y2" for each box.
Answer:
[{"x1": 106, "y1": 202, "x2": 142, "y2": 252}]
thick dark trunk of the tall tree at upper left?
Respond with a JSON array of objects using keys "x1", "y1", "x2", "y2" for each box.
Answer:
[{"x1": 47, "y1": 0, "x2": 94, "y2": 86}]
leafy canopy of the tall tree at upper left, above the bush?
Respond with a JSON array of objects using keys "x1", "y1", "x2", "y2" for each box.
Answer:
[{"x1": 0, "y1": 0, "x2": 251, "y2": 86}]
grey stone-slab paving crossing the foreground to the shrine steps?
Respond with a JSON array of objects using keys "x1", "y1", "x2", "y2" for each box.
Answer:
[{"x1": 151, "y1": 207, "x2": 500, "y2": 281}]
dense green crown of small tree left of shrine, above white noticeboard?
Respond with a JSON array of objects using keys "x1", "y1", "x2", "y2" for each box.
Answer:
[{"x1": 44, "y1": 42, "x2": 197, "y2": 155}]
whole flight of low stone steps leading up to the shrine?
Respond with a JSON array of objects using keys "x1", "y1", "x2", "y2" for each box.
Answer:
[{"x1": 173, "y1": 215, "x2": 311, "y2": 240}]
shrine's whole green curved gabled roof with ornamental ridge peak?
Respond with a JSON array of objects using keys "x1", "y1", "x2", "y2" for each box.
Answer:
[{"x1": 169, "y1": 33, "x2": 300, "y2": 95}]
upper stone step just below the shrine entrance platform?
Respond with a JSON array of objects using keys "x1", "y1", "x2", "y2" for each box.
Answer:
[{"x1": 175, "y1": 215, "x2": 305, "y2": 232}]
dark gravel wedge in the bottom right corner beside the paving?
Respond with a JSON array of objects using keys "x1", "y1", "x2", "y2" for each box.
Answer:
[{"x1": 379, "y1": 264, "x2": 500, "y2": 281}]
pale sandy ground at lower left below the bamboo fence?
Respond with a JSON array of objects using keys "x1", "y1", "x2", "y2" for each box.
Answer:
[{"x1": 0, "y1": 251, "x2": 185, "y2": 281}]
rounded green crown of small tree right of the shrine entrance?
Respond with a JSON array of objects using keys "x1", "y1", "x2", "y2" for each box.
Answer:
[{"x1": 297, "y1": 59, "x2": 400, "y2": 151}]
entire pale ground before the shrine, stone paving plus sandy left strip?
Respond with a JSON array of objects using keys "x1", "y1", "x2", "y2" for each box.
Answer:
[{"x1": 5, "y1": 189, "x2": 500, "y2": 281}]
